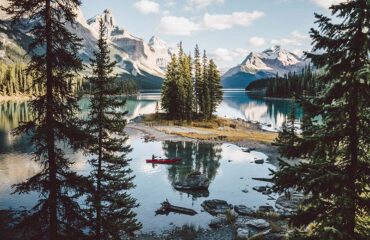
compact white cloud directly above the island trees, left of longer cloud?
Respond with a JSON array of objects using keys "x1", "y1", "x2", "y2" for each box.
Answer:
[{"x1": 158, "y1": 16, "x2": 199, "y2": 36}]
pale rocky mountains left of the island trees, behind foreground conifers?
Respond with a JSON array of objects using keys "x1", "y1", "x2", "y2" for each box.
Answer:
[{"x1": 0, "y1": 4, "x2": 173, "y2": 89}]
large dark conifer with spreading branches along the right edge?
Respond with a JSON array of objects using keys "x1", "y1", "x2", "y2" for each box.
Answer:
[{"x1": 274, "y1": 0, "x2": 370, "y2": 240}]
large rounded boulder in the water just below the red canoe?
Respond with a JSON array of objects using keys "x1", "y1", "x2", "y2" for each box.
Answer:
[{"x1": 174, "y1": 172, "x2": 209, "y2": 190}]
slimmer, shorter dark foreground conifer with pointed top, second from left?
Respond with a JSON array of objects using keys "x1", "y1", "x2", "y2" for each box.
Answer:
[{"x1": 86, "y1": 20, "x2": 141, "y2": 240}]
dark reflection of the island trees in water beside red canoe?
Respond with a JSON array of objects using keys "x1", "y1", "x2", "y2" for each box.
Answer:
[{"x1": 163, "y1": 141, "x2": 222, "y2": 199}]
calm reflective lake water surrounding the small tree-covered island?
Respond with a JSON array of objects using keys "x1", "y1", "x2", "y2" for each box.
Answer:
[{"x1": 0, "y1": 90, "x2": 301, "y2": 232}]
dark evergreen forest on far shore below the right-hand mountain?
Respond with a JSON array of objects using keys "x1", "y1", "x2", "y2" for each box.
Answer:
[{"x1": 246, "y1": 65, "x2": 319, "y2": 98}]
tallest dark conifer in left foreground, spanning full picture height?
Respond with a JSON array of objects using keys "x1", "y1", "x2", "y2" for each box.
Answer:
[{"x1": 4, "y1": 0, "x2": 84, "y2": 239}]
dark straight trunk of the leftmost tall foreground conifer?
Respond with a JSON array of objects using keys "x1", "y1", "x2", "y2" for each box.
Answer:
[{"x1": 45, "y1": 0, "x2": 58, "y2": 240}]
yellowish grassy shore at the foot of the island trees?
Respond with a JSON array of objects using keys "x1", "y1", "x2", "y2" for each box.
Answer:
[{"x1": 143, "y1": 114, "x2": 277, "y2": 143}]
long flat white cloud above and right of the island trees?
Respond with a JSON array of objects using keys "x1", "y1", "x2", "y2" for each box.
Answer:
[{"x1": 203, "y1": 11, "x2": 264, "y2": 30}]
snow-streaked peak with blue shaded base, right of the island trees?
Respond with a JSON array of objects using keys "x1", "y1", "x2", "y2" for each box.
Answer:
[{"x1": 222, "y1": 46, "x2": 309, "y2": 88}]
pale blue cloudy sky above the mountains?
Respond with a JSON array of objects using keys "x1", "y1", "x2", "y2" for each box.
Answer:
[{"x1": 82, "y1": 0, "x2": 343, "y2": 69}]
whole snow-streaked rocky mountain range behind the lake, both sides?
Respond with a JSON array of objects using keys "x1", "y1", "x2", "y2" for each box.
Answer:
[{"x1": 0, "y1": 0, "x2": 308, "y2": 89}]
